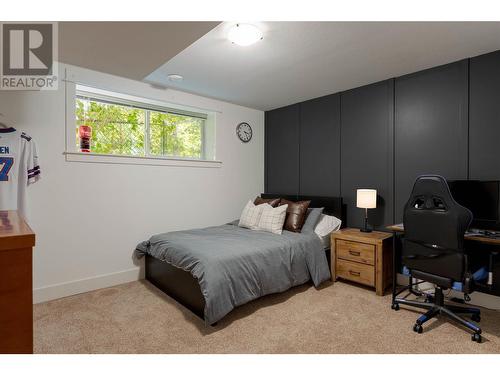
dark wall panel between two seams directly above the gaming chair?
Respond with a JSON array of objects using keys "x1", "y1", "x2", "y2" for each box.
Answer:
[{"x1": 394, "y1": 60, "x2": 468, "y2": 222}]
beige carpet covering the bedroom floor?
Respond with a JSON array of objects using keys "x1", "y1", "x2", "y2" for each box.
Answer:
[{"x1": 35, "y1": 281, "x2": 500, "y2": 353}]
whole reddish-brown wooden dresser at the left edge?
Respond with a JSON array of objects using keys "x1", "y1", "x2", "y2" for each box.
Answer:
[{"x1": 0, "y1": 211, "x2": 35, "y2": 354}]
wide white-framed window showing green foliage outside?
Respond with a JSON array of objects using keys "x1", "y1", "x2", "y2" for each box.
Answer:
[{"x1": 67, "y1": 85, "x2": 219, "y2": 168}]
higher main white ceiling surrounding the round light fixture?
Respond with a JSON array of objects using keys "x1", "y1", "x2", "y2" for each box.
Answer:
[{"x1": 145, "y1": 22, "x2": 500, "y2": 110}]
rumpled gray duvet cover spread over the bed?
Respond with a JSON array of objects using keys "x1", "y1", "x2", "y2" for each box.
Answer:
[{"x1": 137, "y1": 222, "x2": 330, "y2": 324}]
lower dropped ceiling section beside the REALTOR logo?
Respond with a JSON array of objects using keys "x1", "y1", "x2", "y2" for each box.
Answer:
[{"x1": 59, "y1": 22, "x2": 219, "y2": 80}]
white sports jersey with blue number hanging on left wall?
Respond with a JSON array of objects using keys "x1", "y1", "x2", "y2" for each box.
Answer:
[{"x1": 0, "y1": 128, "x2": 40, "y2": 216}]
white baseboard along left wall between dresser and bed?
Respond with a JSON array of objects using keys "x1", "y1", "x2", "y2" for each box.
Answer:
[{"x1": 33, "y1": 267, "x2": 144, "y2": 303}]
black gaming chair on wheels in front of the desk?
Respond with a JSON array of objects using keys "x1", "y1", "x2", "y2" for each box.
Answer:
[{"x1": 392, "y1": 175, "x2": 487, "y2": 342}]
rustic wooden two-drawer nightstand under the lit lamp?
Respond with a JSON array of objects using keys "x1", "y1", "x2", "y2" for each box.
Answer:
[{"x1": 330, "y1": 228, "x2": 392, "y2": 296}]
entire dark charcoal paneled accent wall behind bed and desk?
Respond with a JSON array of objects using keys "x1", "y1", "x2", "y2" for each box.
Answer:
[{"x1": 266, "y1": 51, "x2": 500, "y2": 228}]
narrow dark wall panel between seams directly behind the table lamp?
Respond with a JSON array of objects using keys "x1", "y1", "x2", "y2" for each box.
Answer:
[{"x1": 337, "y1": 80, "x2": 394, "y2": 227}]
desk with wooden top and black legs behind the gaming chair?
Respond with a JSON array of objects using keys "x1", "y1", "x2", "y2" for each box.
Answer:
[{"x1": 386, "y1": 224, "x2": 500, "y2": 296}]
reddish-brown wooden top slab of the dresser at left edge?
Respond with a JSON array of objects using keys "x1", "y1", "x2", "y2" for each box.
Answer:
[{"x1": 0, "y1": 211, "x2": 35, "y2": 251}]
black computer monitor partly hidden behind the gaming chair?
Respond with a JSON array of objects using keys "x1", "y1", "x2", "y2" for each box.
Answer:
[{"x1": 448, "y1": 180, "x2": 500, "y2": 230}]
